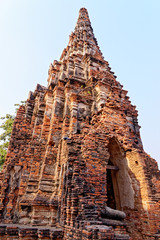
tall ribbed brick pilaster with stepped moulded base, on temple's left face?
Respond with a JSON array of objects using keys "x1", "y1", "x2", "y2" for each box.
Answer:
[{"x1": 17, "y1": 82, "x2": 63, "y2": 225}]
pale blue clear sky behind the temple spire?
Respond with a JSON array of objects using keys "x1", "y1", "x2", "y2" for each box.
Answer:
[{"x1": 0, "y1": 0, "x2": 160, "y2": 165}]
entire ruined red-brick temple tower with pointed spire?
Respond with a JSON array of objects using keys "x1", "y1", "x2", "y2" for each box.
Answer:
[{"x1": 0, "y1": 8, "x2": 160, "y2": 240}]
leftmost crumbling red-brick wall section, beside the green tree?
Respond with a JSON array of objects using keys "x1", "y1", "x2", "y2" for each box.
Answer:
[{"x1": 1, "y1": 106, "x2": 32, "y2": 223}]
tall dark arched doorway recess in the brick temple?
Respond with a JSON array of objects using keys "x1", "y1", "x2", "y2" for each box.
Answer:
[{"x1": 107, "y1": 137, "x2": 134, "y2": 210}]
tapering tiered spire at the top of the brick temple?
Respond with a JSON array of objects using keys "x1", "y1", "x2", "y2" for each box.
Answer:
[{"x1": 48, "y1": 8, "x2": 105, "y2": 86}]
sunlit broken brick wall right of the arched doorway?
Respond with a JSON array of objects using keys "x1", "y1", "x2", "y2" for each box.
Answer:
[{"x1": 127, "y1": 149, "x2": 160, "y2": 236}]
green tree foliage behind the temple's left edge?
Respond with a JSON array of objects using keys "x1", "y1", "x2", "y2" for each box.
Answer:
[{"x1": 0, "y1": 114, "x2": 14, "y2": 168}]
